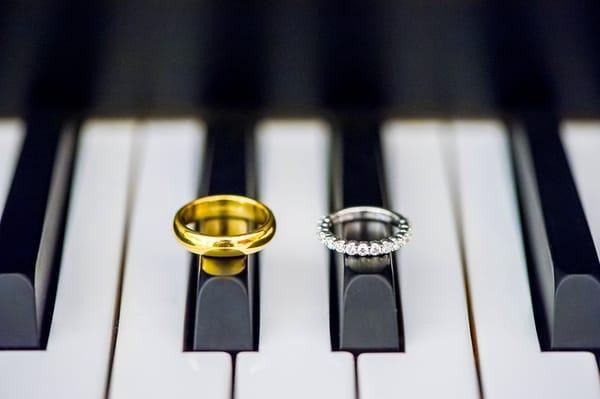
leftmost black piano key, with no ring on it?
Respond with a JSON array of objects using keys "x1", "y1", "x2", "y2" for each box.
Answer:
[{"x1": 0, "y1": 115, "x2": 76, "y2": 349}]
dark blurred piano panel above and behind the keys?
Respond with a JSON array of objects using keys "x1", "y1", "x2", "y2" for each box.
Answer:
[{"x1": 0, "y1": 0, "x2": 600, "y2": 117}]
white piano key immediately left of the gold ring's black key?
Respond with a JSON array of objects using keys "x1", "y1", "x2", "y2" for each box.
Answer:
[{"x1": 110, "y1": 121, "x2": 231, "y2": 399}]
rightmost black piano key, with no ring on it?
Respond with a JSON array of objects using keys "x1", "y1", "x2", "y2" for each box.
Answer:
[{"x1": 512, "y1": 113, "x2": 600, "y2": 351}]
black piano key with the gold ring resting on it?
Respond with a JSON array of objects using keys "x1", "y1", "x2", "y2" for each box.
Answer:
[{"x1": 186, "y1": 120, "x2": 259, "y2": 353}]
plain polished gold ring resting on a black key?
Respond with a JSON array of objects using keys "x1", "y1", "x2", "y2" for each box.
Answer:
[{"x1": 173, "y1": 195, "x2": 275, "y2": 258}]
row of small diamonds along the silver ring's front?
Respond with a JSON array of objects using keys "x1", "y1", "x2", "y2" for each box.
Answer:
[{"x1": 317, "y1": 217, "x2": 410, "y2": 256}]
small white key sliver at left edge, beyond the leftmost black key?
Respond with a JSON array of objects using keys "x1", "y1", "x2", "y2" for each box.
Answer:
[{"x1": 0, "y1": 119, "x2": 25, "y2": 217}]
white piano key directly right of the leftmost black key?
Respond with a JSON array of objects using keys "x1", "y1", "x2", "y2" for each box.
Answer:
[{"x1": 0, "y1": 121, "x2": 133, "y2": 399}]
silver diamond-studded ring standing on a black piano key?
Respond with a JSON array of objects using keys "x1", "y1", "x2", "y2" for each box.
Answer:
[{"x1": 317, "y1": 206, "x2": 411, "y2": 256}]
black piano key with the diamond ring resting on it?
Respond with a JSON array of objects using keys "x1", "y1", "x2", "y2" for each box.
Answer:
[{"x1": 330, "y1": 120, "x2": 403, "y2": 353}]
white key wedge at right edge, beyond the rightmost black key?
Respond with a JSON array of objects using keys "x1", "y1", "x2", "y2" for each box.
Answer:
[{"x1": 561, "y1": 121, "x2": 600, "y2": 253}]
